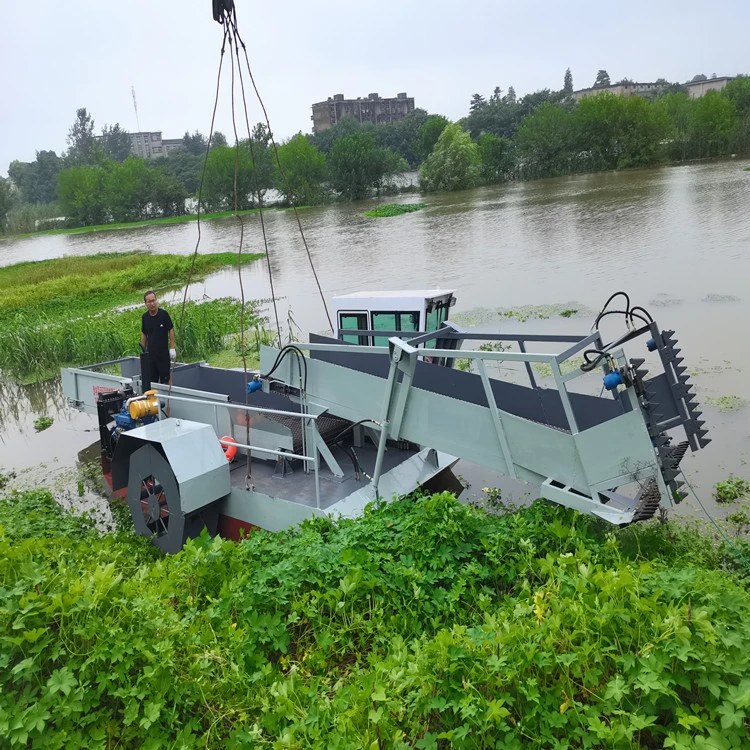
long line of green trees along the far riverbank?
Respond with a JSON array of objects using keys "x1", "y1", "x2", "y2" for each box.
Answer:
[{"x1": 0, "y1": 71, "x2": 750, "y2": 232}]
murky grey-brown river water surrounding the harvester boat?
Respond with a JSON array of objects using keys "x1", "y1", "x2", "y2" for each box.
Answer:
[{"x1": 0, "y1": 160, "x2": 750, "y2": 520}]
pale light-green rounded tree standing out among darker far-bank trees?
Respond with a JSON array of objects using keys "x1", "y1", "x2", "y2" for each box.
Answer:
[{"x1": 419, "y1": 124, "x2": 479, "y2": 192}]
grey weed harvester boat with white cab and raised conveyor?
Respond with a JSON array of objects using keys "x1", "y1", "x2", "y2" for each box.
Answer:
[{"x1": 62, "y1": 290, "x2": 709, "y2": 552}]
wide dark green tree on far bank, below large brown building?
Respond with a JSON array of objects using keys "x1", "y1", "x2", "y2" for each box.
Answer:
[{"x1": 328, "y1": 133, "x2": 404, "y2": 200}]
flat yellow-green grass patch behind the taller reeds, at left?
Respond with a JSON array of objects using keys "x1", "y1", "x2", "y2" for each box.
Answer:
[{"x1": 0, "y1": 252, "x2": 263, "y2": 326}]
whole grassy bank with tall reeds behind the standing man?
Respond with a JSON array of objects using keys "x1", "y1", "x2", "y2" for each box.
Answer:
[{"x1": 0, "y1": 253, "x2": 262, "y2": 382}]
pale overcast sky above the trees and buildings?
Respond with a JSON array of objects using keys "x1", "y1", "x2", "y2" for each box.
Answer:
[{"x1": 0, "y1": 0, "x2": 750, "y2": 175}]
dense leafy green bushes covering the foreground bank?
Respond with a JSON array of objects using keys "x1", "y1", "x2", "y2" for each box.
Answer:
[{"x1": 0, "y1": 493, "x2": 750, "y2": 749}]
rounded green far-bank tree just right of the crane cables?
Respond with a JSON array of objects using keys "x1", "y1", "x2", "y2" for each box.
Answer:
[{"x1": 274, "y1": 133, "x2": 327, "y2": 206}]
